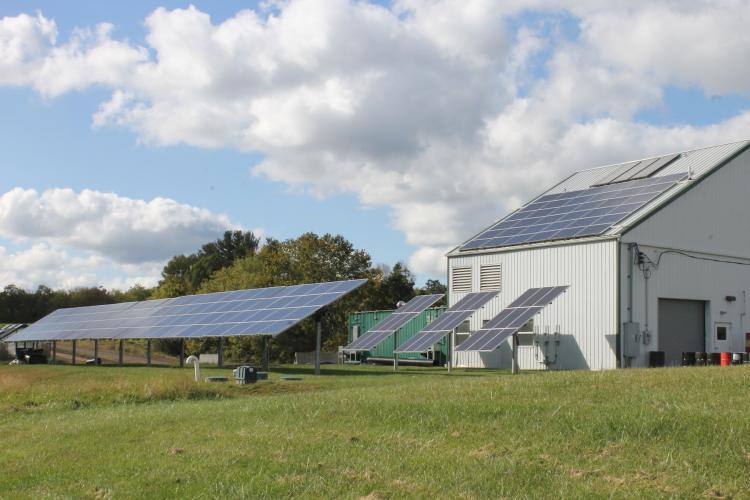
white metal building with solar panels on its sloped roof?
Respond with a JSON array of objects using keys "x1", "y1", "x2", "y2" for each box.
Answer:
[{"x1": 448, "y1": 141, "x2": 750, "y2": 370}]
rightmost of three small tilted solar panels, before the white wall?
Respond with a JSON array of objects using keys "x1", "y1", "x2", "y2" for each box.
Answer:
[{"x1": 456, "y1": 286, "x2": 568, "y2": 352}]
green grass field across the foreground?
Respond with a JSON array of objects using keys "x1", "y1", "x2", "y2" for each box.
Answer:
[{"x1": 0, "y1": 366, "x2": 750, "y2": 499}]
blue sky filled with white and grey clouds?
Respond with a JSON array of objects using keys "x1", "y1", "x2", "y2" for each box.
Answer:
[{"x1": 0, "y1": 0, "x2": 750, "y2": 289}]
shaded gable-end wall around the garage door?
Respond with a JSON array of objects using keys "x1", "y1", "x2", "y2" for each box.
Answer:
[{"x1": 620, "y1": 151, "x2": 750, "y2": 366}]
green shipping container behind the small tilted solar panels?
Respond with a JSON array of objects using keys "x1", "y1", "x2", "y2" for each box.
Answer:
[{"x1": 349, "y1": 307, "x2": 448, "y2": 364}]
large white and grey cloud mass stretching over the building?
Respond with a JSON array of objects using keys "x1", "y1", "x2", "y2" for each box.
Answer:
[{"x1": 0, "y1": 0, "x2": 750, "y2": 272}]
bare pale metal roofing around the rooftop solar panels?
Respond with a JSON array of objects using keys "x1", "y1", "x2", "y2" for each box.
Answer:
[{"x1": 448, "y1": 140, "x2": 750, "y2": 255}]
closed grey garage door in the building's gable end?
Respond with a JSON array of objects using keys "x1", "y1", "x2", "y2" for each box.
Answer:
[{"x1": 657, "y1": 299, "x2": 706, "y2": 366}]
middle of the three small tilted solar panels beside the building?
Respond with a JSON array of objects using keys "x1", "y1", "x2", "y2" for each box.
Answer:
[{"x1": 393, "y1": 292, "x2": 498, "y2": 353}]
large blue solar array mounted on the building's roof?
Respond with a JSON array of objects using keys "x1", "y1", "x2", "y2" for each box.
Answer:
[{"x1": 461, "y1": 174, "x2": 686, "y2": 250}]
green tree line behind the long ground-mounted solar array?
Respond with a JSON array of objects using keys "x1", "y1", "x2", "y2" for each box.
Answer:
[{"x1": 0, "y1": 231, "x2": 445, "y2": 362}]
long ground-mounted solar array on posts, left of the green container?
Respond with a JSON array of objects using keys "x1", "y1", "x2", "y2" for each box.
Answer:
[{"x1": 5, "y1": 280, "x2": 367, "y2": 342}]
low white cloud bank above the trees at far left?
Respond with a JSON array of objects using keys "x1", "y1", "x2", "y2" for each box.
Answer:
[{"x1": 0, "y1": 188, "x2": 237, "y2": 264}]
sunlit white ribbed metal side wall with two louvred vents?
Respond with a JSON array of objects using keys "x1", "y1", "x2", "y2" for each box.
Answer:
[{"x1": 448, "y1": 240, "x2": 617, "y2": 369}]
